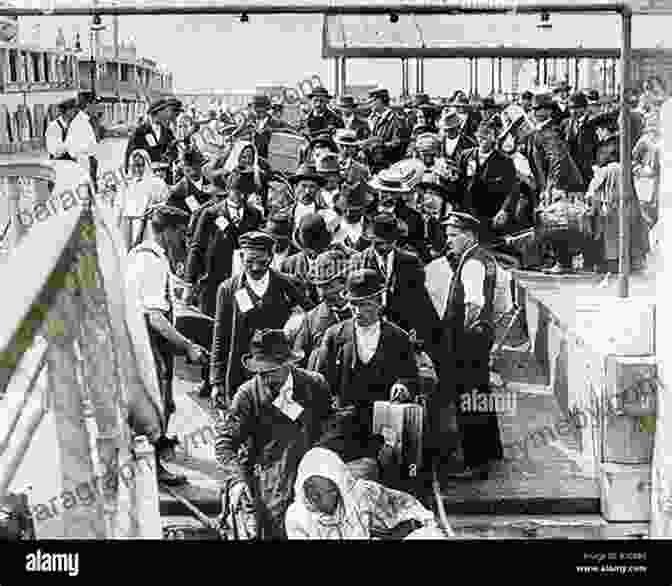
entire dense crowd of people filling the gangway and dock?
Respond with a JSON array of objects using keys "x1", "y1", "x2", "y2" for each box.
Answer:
[{"x1": 46, "y1": 79, "x2": 664, "y2": 539}]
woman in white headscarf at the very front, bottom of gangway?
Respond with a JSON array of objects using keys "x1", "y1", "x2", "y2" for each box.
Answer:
[{"x1": 285, "y1": 448, "x2": 452, "y2": 540}]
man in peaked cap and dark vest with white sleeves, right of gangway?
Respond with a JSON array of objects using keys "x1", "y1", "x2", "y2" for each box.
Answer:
[{"x1": 426, "y1": 212, "x2": 503, "y2": 478}]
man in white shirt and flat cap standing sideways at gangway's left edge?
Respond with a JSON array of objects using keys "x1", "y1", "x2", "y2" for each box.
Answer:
[{"x1": 125, "y1": 205, "x2": 207, "y2": 485}]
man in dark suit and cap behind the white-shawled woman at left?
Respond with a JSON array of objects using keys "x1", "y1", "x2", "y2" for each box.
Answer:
[{"x1": 124, "y1": 98, "x2": 183, "y2": 178}]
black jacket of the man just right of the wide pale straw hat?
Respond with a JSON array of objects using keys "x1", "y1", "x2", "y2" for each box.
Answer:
[{"x1": 460, "y1": 148, "x2": 520, "y2": 219}]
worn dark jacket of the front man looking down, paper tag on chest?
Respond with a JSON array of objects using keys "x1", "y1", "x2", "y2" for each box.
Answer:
[{"x1": 215, "y1": 368, "x2": 331, "y2": 538}]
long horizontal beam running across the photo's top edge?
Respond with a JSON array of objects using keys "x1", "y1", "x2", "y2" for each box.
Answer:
[{"x1": 0, "y1": 0, "x2": 672, "y2": 16}]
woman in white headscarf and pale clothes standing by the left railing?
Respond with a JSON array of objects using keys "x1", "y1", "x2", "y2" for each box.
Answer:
[{"x1": 119, "y1": 149, "x2": 168, "y2": 250}]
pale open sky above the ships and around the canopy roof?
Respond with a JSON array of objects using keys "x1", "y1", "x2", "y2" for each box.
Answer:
[{"x1": 15, "y1": 15, "x2": 672, "y2": 95}]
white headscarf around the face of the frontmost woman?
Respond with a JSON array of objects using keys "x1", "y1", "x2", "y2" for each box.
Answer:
[{"x1": 287, "y1": 448, "x2": 370, "y2": 539}]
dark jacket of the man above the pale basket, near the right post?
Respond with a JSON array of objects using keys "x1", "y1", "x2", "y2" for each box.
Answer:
[{"x1": 530, "y1": 122, "x2": 586, "y2": 193}]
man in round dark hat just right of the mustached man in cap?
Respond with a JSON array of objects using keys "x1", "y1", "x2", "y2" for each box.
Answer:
[{"x1": 280, "y1": 213, "x2": 331, "y2": 307}]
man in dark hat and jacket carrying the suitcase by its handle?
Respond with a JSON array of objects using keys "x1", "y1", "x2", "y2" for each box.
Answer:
[{"x1": 314, "y1": 268, "x2": 418, "y2": 463}]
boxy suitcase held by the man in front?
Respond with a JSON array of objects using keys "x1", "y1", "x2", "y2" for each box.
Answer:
[{"x1": 373, "y1": 401, "x2": 425, "y2": 478}]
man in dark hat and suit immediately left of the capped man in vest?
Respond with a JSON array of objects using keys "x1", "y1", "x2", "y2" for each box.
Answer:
[{"x1": 351, "y1": 213, "x2": 437, "y2": 354}]
